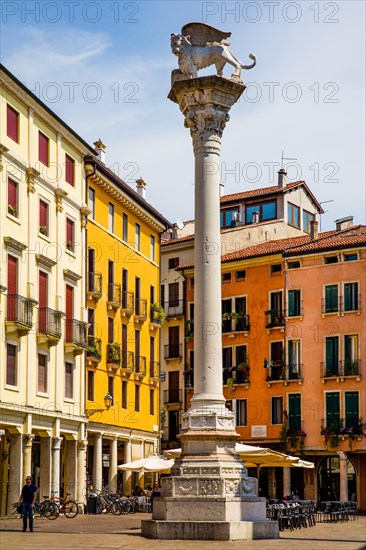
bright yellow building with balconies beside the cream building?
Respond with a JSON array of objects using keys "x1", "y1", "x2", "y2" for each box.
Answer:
[{"x1": 85, "y1": 151, "x2": 169, "y2": 493}]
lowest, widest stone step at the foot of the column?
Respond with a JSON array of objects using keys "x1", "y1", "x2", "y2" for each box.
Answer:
[{"x1": 141, "y1": 519, "x2": 278, "y2": 540}]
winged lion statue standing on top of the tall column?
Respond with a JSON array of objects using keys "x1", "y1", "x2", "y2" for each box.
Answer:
[{"x1": 170, "y1": 23, "x2": 257, "y2": 78}]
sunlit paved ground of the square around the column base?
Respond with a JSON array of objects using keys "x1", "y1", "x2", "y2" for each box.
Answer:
[{"x1": 0, "y1": 514, "x2": 366, "y2": 550}]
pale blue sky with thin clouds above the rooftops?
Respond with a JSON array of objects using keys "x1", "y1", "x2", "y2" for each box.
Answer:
[{"x1": 1, "y1": 0, "x2": 365, "y2": 230}]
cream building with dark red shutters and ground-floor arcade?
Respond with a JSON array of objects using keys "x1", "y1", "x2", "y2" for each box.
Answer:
[{"x1": 0, "y1": 66, "x2": 94, "y2": 513}]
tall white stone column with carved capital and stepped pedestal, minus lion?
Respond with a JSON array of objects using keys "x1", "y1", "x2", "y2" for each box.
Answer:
[{"x1": 141, "y1": 76, "x2": 278, "y2": 540}]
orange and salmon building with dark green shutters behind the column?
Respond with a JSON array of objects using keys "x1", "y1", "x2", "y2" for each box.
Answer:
[{"x1": 179, "y1": 220, "x2": 366, "y2": 510}]
